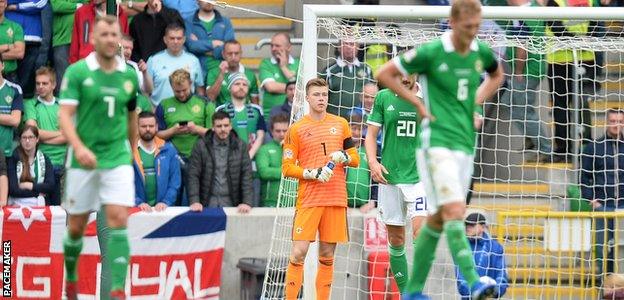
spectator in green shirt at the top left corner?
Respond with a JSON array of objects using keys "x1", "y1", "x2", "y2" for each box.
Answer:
[{"x1": 0, "y1": 0, "x2": 26, "y2": 83}]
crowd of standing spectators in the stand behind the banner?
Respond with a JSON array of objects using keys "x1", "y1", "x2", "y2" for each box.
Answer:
[{"x1": 0, "y1": 0, "x2": 377, "y2": 212}]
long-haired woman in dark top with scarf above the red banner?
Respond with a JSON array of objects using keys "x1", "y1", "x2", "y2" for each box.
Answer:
[{"x1": 7, "y1": 125, "x2": 56, "y2": 206}]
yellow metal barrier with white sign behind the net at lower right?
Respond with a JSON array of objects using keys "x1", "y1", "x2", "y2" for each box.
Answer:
[{"x1": 500, "y1": 211, "x2": 624, "y2": 299}]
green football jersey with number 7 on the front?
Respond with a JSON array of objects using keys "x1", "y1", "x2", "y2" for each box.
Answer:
[{"x1": 59, "y1": 52, "x2": 139, "y2": 169}]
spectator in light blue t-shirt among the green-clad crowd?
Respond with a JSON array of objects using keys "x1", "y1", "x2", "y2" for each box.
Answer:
[{"x1": 147, "y1": 23, "x2": 206, "y2": 106}]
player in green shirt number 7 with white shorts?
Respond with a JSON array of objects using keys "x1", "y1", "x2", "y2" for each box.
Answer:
[{"x1": 59, "y1": 16, "x2": 139, "y2": 299}]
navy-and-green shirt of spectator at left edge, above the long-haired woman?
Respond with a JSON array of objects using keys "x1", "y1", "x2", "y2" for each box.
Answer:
[{"x1": 0, "y1": 79, "x2": 24, "y2": 157}]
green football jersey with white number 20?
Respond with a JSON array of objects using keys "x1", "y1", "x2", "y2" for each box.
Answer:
[{"x1": 367, "y1": 89, "x2": 422, "y2": 184}]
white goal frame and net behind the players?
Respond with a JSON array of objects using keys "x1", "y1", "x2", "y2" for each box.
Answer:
[{"x1": 263, "y1": 6, "x2": 624, "y2": 299}]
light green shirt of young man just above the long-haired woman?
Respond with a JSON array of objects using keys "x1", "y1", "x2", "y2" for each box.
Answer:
[{"x1": 24, "y1": 98, "x2": 67, "y2": 166}]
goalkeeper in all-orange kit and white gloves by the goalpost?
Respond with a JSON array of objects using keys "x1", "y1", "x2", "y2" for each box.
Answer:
[{"x1": 282, "y1": 78, "x2": 360, "y2": 300}]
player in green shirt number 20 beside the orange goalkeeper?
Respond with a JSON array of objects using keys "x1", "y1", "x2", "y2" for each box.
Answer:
[{"x1": 366, "y1": 76, "x2": 427, "y2": 291}]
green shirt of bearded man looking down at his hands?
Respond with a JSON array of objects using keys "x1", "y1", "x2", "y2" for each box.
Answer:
[{"x1": 156, "y1": 95, "x2": 215, "y2": 158}]
